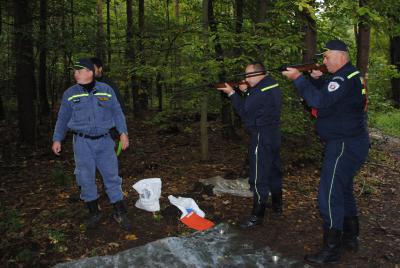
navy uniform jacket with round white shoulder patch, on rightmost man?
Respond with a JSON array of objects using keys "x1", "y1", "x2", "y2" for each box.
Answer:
[{"x1": 294, "y1": 62, "x2": 367, "y2": 141}]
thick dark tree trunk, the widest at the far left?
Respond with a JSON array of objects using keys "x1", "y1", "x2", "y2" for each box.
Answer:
[{"x1": 13, "y1": 0, "x2": 36, "y2": 146}]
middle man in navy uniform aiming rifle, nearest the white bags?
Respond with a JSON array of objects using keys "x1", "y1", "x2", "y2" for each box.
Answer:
[{"x1": 219, "y1": 62, "x2": 282, "y2": 228}]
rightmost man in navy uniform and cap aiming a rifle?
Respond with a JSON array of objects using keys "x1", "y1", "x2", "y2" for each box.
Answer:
[{"x1": 282, "y1": 40, "x2": 369, "y2": 264}]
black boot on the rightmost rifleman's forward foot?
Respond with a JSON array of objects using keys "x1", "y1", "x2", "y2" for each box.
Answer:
[{"x1": 304, "y1": 229, "x2": 342, "y2": 264}]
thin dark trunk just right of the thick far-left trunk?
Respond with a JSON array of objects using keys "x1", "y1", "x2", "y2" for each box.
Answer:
[{"x1": 39, "y1": 0, "x2": 50, "y2": 116}]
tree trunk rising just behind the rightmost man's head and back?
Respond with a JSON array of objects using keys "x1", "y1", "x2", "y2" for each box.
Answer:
[{"x1": 356, "y1": 0, "x2": 371, "y2": 78}]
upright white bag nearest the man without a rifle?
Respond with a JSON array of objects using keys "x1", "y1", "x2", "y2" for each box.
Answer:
[{"x1": 132, "y1": 178, "x2": 161, "y2": 212}]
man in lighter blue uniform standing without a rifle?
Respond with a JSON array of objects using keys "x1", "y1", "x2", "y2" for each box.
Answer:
[{"x1": 52, "y1": 58, "x2": 132, "y2": 230}]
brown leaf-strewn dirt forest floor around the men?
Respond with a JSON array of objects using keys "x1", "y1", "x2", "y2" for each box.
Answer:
[{"x1": 0, "y1": 114, "x2": 400, "y2": 267}]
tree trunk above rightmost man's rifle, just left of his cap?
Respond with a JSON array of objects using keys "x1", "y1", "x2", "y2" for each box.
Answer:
[{"x1": 301, "y1": 1, "x2": 317, "y2": 63}]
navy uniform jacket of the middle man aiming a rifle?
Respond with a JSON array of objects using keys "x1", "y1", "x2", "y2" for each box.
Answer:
[{"x1": 231, "y1": 76, "x2": 282, "y2": 131}]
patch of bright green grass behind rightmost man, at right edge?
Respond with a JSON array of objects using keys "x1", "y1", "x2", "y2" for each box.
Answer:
[{"x1": 369, "y1": 110, "x2": 400, "y2": 137}]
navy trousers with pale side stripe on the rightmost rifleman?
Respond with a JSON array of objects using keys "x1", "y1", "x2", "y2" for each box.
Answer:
[{"x1": 318, "y1": 134, "x2": 369, "y2": 230}]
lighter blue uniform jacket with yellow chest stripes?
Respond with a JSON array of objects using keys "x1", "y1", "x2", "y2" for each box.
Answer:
[{"x1": 53, "y1": 81, "x2": 128, "y2": 141}]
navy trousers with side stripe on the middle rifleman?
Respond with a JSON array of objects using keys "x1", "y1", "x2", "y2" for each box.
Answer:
[{"x1": 249, "y1": 126, "x2": 282, "y2": 203}]
